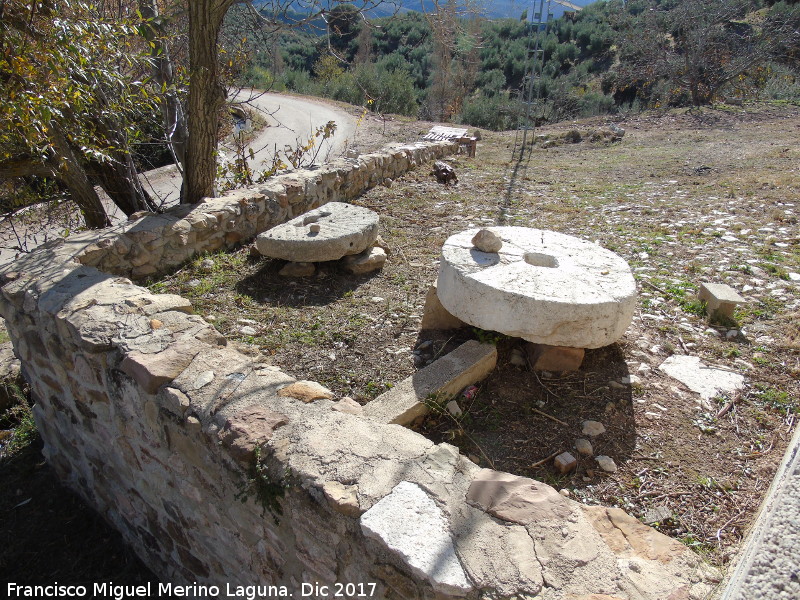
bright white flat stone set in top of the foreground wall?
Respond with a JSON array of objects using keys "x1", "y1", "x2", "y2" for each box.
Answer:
[{"x1": 361, "y1": 481, "x2": 472, "y2": 596}]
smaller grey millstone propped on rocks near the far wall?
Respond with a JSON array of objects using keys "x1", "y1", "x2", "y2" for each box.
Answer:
[{"x1": 256, "y1": 202, "x2": 378, "y2": 262}]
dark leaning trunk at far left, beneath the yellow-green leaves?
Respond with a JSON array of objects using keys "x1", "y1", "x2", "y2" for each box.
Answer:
[{"x1": 47, "y1": 122, "x2": 111, "y2": 229}]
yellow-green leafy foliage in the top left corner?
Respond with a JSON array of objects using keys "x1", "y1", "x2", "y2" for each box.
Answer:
[{"x1": 0, "y1": 0, "x2": 155, "y2": 171}]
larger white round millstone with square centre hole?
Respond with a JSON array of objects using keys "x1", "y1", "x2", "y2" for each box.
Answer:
[{"x1": 437, "y1": 227, "x2": 636, "y2": 348}]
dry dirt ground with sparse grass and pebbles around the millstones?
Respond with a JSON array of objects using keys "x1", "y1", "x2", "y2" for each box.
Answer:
[{"x1": 0, "y1": 106, "x2": 800, "y2": 572}]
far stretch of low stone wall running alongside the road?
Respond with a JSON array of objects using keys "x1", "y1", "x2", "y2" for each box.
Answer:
[{"x1": 75, "y1": 142, "x2": 458, "y2": 279}]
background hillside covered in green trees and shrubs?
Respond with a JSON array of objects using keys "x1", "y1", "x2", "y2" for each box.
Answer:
[{"x1": 241, "y1": 0, "x2": 800, "y2": 130}]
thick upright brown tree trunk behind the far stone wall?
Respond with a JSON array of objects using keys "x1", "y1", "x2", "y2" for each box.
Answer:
[{"x1": 188, "y1": 0, "x2": 233, "y2": 204}]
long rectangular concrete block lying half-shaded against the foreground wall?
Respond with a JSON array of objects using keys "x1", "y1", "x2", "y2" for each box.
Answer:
[{"x1": 364, "y1": 340, "x2": 497, "y2": 425}]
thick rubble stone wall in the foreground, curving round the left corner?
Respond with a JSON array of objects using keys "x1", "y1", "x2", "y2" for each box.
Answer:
[{"x1": 0, "y1": 145, "x2": 715, "y2": 600}]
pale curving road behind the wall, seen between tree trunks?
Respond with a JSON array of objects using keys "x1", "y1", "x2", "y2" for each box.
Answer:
[{"x1": 0, "y1": 90, "x2": 356, "y2": 264}]
